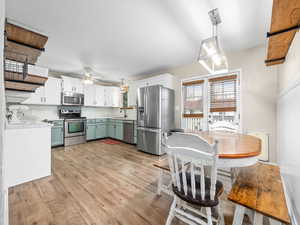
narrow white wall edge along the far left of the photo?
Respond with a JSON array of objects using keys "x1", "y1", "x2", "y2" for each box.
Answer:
[{"x1": 0, "y1": 0, "x2": 8, "y2": 224}]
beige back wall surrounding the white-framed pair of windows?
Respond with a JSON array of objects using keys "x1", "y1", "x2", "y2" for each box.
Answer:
[{"x1": 148, "y1": 46, "x2": 277, "y2": 162}]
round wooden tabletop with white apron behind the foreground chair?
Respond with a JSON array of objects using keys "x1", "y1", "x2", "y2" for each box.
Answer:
[{"x1": 185, "y1": 130, "x2": 261, "y2": 168}]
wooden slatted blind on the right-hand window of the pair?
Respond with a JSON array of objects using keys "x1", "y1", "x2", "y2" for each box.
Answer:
[{"x1": 209, "y1": 75, "x2": 237, "y2": 112}]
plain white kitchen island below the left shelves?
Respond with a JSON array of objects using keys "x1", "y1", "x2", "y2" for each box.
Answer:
[{"x1": 4, "y1": 122, "x2": 51, "y2": 188}]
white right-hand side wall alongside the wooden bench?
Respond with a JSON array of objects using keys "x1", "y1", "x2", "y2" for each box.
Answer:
[{"x1": 278, "y1": 33, "x2": 300, "y2": 224}]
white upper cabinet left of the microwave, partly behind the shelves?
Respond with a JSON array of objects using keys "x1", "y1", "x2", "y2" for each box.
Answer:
[{"x1": 22, "y1": 77, "x2": 61, "y2": 105}]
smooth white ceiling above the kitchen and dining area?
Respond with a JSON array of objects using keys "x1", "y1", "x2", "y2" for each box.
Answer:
[{"x1": 6, "y1": 0, "x2": 272, "y2": 79}]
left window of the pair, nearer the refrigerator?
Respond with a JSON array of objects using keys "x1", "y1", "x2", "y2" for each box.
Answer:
[{"x1": 182, "y1": 80, "x2": 204, "y2": 117}]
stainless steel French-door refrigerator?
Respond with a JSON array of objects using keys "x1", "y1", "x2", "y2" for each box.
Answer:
[{"x1": 137, "y1": 85, "x2": 175, "y2": 155}]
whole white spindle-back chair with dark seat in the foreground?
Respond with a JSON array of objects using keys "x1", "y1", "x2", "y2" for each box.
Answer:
[{"x1": 163, "y1": 133, "x2": 224, "y2": 225}]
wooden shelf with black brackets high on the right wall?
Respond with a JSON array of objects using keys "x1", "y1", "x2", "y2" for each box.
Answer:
[{"x1": 265, "y1": 0, "x2": 300, "y2": 66}]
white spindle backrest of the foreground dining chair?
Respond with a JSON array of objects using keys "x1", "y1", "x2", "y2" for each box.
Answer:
[{"x1": 163, "y1": 133, "x2": 218, "y2": 200}]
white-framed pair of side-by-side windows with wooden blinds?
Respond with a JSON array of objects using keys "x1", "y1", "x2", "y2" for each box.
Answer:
[{"x1": 181, "y1": 74, "x2": 240, "y2": 130}]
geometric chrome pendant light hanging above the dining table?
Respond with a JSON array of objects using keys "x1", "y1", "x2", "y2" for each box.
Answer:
[{"x1": 198, "y1": 9, "x2": 228, "y2": 73}]
